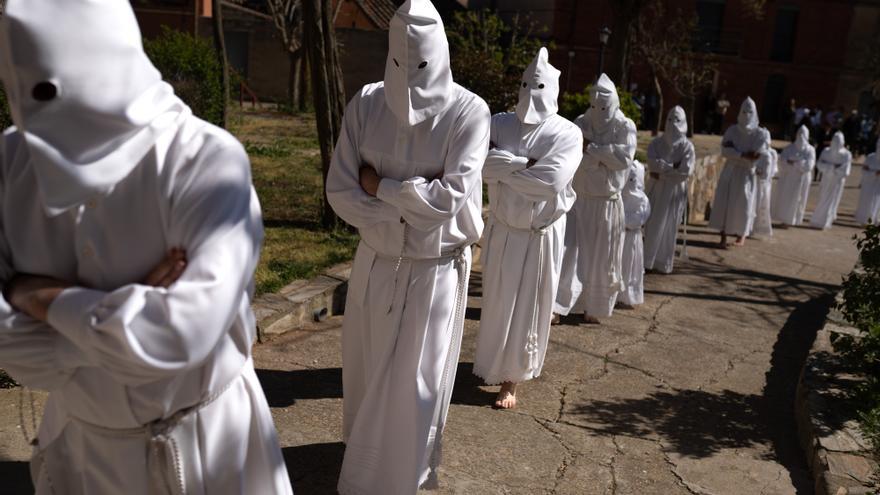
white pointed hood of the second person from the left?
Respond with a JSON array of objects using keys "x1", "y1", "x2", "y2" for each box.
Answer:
[{"x1": 385, "y1": 0, "x2": 453, "y2": 126}]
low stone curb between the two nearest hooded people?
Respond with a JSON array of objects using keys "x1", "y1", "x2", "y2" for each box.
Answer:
[{"x1": 252, "y1": 263, "x2": 351, "y2": 341}]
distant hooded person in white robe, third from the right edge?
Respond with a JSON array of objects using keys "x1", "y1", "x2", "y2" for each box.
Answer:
[{"x1": 772, "y1": 125, "x2": 816, "y2": 225}]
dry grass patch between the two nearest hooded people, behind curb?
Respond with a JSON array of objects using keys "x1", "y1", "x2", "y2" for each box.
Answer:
[{"x1": 229, "y1": 110, "x2": 357, "y2": 294}]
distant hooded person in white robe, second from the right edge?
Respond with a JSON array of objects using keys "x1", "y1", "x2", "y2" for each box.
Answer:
[{"x1": 810, "y1": 131, "x2": 852, "y2": 230}]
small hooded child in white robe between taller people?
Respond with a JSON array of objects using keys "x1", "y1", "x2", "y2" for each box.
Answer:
[{"x1": 619, "y1": 160, "x2": 651, "y2": 306}]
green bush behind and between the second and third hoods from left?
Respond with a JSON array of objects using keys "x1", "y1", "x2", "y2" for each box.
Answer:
[{"x1": 446, "y1": 10, "x2": 549, "y2": 114}]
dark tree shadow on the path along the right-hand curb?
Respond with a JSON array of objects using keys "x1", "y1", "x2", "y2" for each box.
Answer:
[{"x1": 573, "y1": 293, "x2": 833, "y2": 494}]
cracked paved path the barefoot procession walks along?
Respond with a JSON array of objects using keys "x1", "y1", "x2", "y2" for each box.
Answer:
[{"x1": 0, "y1": 166, "x2": 859, "y2": 495}]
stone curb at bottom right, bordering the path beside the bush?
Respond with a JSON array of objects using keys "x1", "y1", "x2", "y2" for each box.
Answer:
[{"x1": 794, "y1": 298, "x2": 878, "y2": 495}]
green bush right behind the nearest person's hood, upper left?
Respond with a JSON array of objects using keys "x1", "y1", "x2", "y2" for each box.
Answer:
[{"x1": 144, "y1": 27, "x2": 226, "y2": 125}]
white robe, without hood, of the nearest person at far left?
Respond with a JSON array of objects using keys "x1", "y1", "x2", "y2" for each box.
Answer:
[{"x1": 0, "y1": 118, "x2": 292, "y2": 495}]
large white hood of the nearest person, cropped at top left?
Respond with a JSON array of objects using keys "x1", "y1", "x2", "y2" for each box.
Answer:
[{"x1": 0, "y1": 0, "x2": 188, "y2": 215}]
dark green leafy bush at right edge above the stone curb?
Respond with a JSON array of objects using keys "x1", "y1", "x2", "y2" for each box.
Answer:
[{"x1": 833, "y1": 225, "x2": 880, "y2": 462}]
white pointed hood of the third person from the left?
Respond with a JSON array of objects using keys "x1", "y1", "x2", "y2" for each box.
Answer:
[{"x1": 516, "y1": 47, "x2": 560, "y2": 124}]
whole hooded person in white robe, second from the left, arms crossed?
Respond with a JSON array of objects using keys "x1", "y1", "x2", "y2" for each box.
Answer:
[{"x1": 327, "y1": 0, "x2": 491, "y2": 495}]
